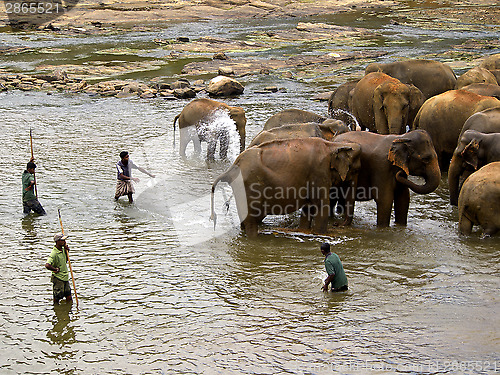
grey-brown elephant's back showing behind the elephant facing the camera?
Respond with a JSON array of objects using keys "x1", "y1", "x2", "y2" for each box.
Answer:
[{"x1": 365, "y1": 59, "x2": 457, "y2": 100}]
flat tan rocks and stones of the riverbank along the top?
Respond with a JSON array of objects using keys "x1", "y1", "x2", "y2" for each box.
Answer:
[{"x1": 0, "y1": 0, "x2": 500, "y2": 99}]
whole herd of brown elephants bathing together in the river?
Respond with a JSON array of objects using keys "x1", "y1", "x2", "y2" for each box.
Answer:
[{"x1": 174, "y1": 54, "x2": 500, "y2": 237}]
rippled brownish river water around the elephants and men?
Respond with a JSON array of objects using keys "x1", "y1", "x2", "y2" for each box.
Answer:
[{"x1": 0, "y1": 3, "x2": 500, "y2": 374}]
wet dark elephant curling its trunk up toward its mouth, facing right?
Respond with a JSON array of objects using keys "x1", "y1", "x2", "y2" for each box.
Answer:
[{"x1": 335, "y1": 130, "x2": 441, "y2": 227}]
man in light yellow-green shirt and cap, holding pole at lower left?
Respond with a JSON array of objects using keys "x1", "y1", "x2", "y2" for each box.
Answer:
[{"x1": 45, "y1": 233, "x2": 72, "y2": 305}]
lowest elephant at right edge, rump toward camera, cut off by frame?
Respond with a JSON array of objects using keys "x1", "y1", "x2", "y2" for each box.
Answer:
[{"x1": 458, "y1": 161, "x2": 500, "y2": 236}]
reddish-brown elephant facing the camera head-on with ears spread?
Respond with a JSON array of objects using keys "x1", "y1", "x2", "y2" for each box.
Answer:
[{"x1": 349, "y1": 72, "x2": 424, "y2": 134}]
